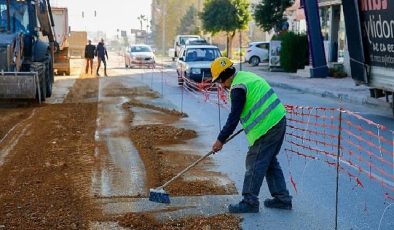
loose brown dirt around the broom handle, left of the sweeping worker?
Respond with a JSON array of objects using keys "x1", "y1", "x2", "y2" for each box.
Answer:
[{"x1": 129, "y1": 108, "x2": 237, "y2": 196}]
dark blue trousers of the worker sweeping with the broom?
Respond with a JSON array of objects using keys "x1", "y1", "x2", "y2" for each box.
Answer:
[{"x1": 242, "y1": 117, "x2": 292, "y2": 204}]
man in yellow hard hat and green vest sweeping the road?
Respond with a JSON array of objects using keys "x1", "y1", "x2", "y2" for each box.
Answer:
[{"x1": 211, "y1": 57, "x2": 292, "y2": 213}]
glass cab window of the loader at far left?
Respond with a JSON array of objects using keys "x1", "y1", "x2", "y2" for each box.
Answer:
[{"x1": 0, "y1": 0, "x2": 29, "y2": 32}]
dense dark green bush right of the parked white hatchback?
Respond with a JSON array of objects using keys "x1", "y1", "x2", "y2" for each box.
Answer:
[{"x1": 275, "y1": 32, "x2": 309, "y2": 73}]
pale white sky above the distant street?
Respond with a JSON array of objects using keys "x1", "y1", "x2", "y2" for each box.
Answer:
[{"x1": 50, "y1": 0, "x2": 152, "y2": 35}]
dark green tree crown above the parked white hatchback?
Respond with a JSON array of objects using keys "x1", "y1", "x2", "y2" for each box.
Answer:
[{"x1": 253, "y1": 0, "x2": 293, "y2": 31}]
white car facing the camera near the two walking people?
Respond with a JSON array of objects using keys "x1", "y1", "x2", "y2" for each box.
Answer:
[{"x1": 125, "y1": 44, "x2": 156, "y2": 68}]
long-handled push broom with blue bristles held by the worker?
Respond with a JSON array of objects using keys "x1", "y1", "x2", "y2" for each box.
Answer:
[{"x1": 149, "y1": 129, "x2": 243, "y2": 204}]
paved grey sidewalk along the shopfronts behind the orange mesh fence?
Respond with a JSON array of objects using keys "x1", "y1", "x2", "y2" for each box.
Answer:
[{"x1": 237, "y1": 63, "x2": 390, "y2": 109}]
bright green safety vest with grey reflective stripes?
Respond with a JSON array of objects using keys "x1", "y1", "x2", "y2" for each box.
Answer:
[{"x1": 230, "y1": 71, "x2": 286, "y2": 146}]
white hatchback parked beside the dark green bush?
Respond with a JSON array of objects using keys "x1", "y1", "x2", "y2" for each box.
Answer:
[{"x1": 245, "y1": 41, "x2": 270, "y2": 66}]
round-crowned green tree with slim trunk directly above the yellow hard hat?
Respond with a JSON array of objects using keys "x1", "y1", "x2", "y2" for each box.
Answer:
[{"x1": 200, "y1": 0, "x2": 250, "y2": 58}]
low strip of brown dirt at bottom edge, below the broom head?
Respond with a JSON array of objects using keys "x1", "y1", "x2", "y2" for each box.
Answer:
[{"x1": 119, "y1": 213, "x2": 241, "y2": 230}]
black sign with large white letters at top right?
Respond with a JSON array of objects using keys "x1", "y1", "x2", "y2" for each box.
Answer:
[{"x1": 358, "y1": 0, "x2": 394, "y2": 68}]
